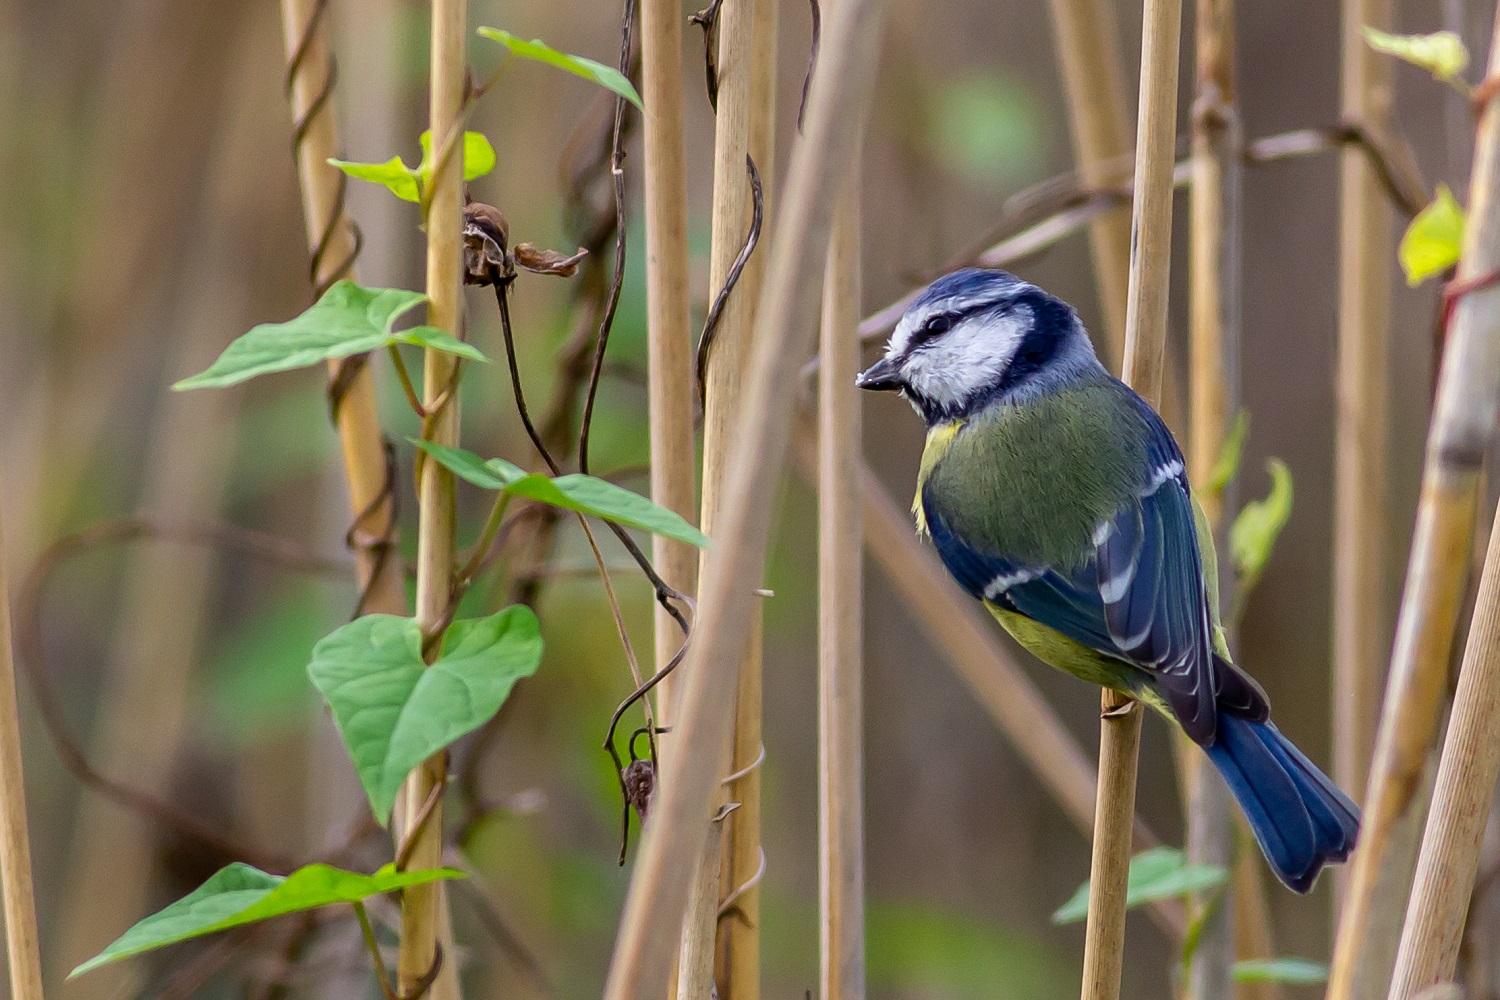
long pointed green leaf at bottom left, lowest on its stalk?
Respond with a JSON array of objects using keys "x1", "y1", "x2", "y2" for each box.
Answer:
[{"x1": 68, "y1": 862, "x2": 464, "y2": 979}]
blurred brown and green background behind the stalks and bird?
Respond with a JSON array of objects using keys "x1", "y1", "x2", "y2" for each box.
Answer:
[{"x1": 0, "y1": 0, "x2": 1490, "y2": 1000}]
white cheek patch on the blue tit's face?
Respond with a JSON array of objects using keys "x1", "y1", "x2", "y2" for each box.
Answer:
[{"x1": 891, "y1": 309, "x2": 1031, "y2": 406}]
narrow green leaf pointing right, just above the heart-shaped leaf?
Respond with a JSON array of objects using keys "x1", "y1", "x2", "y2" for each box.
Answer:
[{"x1": 411, "y1": 438, "x2": 708, "y2": 549}]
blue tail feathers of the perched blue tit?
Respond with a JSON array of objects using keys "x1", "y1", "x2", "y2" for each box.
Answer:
[{"x1": 1208, "y1": 712, "x2": 1359, "y2": 892}]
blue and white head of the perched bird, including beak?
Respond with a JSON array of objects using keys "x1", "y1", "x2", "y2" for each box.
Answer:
[{"x1": 855, "y1": 268, "x2": 1098, "y2": 423}]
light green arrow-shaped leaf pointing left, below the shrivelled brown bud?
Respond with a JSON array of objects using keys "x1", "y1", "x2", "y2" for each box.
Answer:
[{"x1": 173, "y1": 280, "x2": 489, "y2": 390}]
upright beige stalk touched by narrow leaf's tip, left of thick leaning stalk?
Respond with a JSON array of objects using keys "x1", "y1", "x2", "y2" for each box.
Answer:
[{"x1": 641, "y1": 0, "x2": 698, "y2": 726}]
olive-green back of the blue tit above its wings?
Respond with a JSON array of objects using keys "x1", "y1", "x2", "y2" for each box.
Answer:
[{"x1": 918, "y1": 378, "x2": 1149, "y2": 568}]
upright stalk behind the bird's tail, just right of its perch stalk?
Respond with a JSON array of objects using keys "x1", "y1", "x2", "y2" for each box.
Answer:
[{"x1": 1176, "y1": 0, "x2": 1241, "y2": 1000}]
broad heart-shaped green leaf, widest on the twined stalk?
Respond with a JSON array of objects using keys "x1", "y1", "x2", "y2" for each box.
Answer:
[{"x1": 308, "y1": 604, "x2": 542, "y2": 825}]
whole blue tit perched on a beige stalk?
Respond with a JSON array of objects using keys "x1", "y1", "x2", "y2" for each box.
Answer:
[{"x1": 857, "y1": 270, "x2": 1359, "y2": 892}]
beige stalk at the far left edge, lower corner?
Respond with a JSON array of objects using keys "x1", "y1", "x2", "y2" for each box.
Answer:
[{"x1": 0, "y1": 509, "x2": 42, "y2": 1000}]
